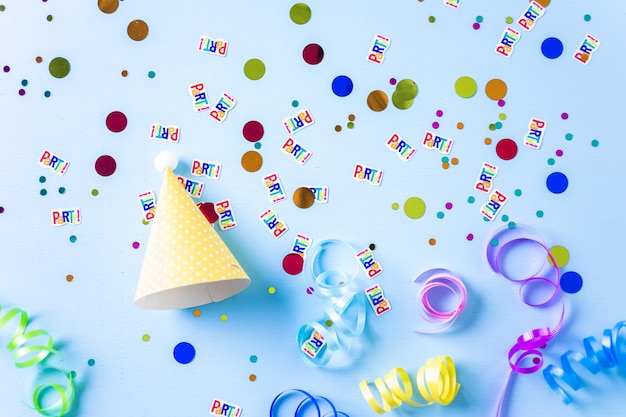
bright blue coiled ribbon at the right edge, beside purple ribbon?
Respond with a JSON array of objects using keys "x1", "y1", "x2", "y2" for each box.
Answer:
[{"x1": 543, "y1": 321, "x2": 626, "y2": 404}]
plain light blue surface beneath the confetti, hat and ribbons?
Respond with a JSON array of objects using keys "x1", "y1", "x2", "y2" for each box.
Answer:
[{"x1": 0, "y1": 0, "x2": 626, "y2": 417}]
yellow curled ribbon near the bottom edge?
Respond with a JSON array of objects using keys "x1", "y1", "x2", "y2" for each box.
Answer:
[{"x1": 359, "y1": 356, "x2": 461, "y2": 414}]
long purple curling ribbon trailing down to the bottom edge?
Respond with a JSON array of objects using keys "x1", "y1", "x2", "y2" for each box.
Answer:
[{"x1": 487, "y1": 225, "x2": 565, "y2": 417}]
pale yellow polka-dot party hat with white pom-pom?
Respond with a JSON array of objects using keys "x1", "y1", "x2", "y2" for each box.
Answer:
[{"x1": 135, "y1": 153, "x2": 250, "y2": 309}]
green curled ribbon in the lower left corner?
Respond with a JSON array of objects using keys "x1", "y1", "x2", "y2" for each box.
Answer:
[{"x1": 0, "y1": 306, "x2": 74, "y2": 417}]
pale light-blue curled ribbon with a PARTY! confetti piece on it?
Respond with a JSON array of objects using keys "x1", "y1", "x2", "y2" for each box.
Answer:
[{"x1": 297, "y1": 239, "x2": 366, "y2": 366}]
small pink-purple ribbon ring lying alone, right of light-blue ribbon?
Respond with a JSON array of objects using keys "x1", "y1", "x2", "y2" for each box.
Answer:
[{"x1": 414, "y1": 268, "x2": 467, "y2": 333}]
